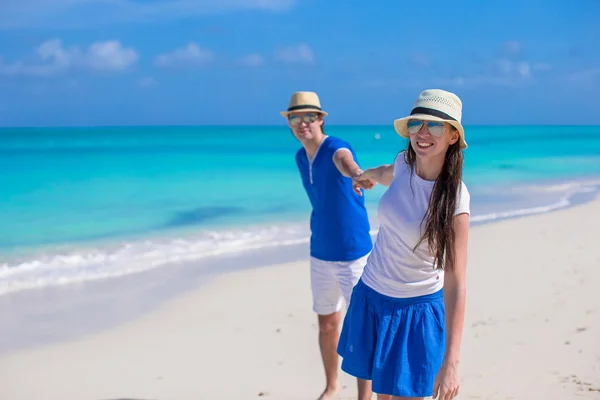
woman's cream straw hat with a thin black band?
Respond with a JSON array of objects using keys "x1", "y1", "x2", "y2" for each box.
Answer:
[{"x1": 394, "y1": 89, "x2": 467, "y2": 149}]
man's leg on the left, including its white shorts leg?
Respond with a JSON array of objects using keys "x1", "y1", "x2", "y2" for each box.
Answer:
[{"x1": 310, "y1": 258, "x2": 344, "y2": 400}]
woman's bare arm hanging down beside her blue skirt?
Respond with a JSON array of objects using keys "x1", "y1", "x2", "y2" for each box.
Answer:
[{"x1": 434, "y1": 213, "x2": 469, "y2": 399}]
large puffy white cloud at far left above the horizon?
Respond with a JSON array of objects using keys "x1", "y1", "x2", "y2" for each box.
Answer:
[{"x1": 0, "y1": 39, "x2": 139, "y2": 77}]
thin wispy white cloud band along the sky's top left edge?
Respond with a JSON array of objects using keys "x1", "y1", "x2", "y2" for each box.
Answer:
[{"x1": 0, "y1": 0, "x2": 297, "y2": 29}]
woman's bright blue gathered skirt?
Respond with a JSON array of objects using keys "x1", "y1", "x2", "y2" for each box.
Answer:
[{"x1": 337, "y1": 280, "x2": 446, "y2": 397}]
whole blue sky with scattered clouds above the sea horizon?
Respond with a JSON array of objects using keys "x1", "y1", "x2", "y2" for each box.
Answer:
[{"x1": 0, "y1": 0, "x2": 600, "y2": 126}]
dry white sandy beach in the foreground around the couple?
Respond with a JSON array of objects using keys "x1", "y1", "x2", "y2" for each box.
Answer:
[{"x1": 0, "y1": 200, "x2": 600, "y2": 400}]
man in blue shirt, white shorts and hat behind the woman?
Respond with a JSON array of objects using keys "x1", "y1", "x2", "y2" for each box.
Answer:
[{"x1": 281, "y1": 92, "x2": 373, "y2": 400}]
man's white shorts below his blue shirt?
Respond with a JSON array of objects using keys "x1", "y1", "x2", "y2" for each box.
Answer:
[{"x1": 310, "y1": 254, "x2": 369, "y2": 315}]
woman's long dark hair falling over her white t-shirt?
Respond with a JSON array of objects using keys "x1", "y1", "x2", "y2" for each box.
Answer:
[{"x1": 405, "y1": 127, "x2": 464, "y2": 271}]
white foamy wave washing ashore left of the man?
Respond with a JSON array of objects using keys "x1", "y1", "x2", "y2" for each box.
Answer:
[{"x1": 0, "y1": 225, "x2": 308, "y2": 295}]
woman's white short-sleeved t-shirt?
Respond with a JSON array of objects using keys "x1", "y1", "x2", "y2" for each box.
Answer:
[{"x1": 362, "y1": 152, "x2": 471, "y2": 297}]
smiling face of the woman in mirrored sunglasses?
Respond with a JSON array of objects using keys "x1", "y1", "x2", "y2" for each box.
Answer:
[{"x1": 407, "y1": 119, "x2": 459, "y2": 158}]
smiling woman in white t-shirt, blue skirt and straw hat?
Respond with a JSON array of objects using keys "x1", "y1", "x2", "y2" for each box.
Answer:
[{"x1": 338, "y1": 89, "x2": 470, "y2": 400}]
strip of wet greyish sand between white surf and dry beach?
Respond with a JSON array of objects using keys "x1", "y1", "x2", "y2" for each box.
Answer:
[{"x1": 0, "y1": 183, "x2": 600, "y2": 357}]
